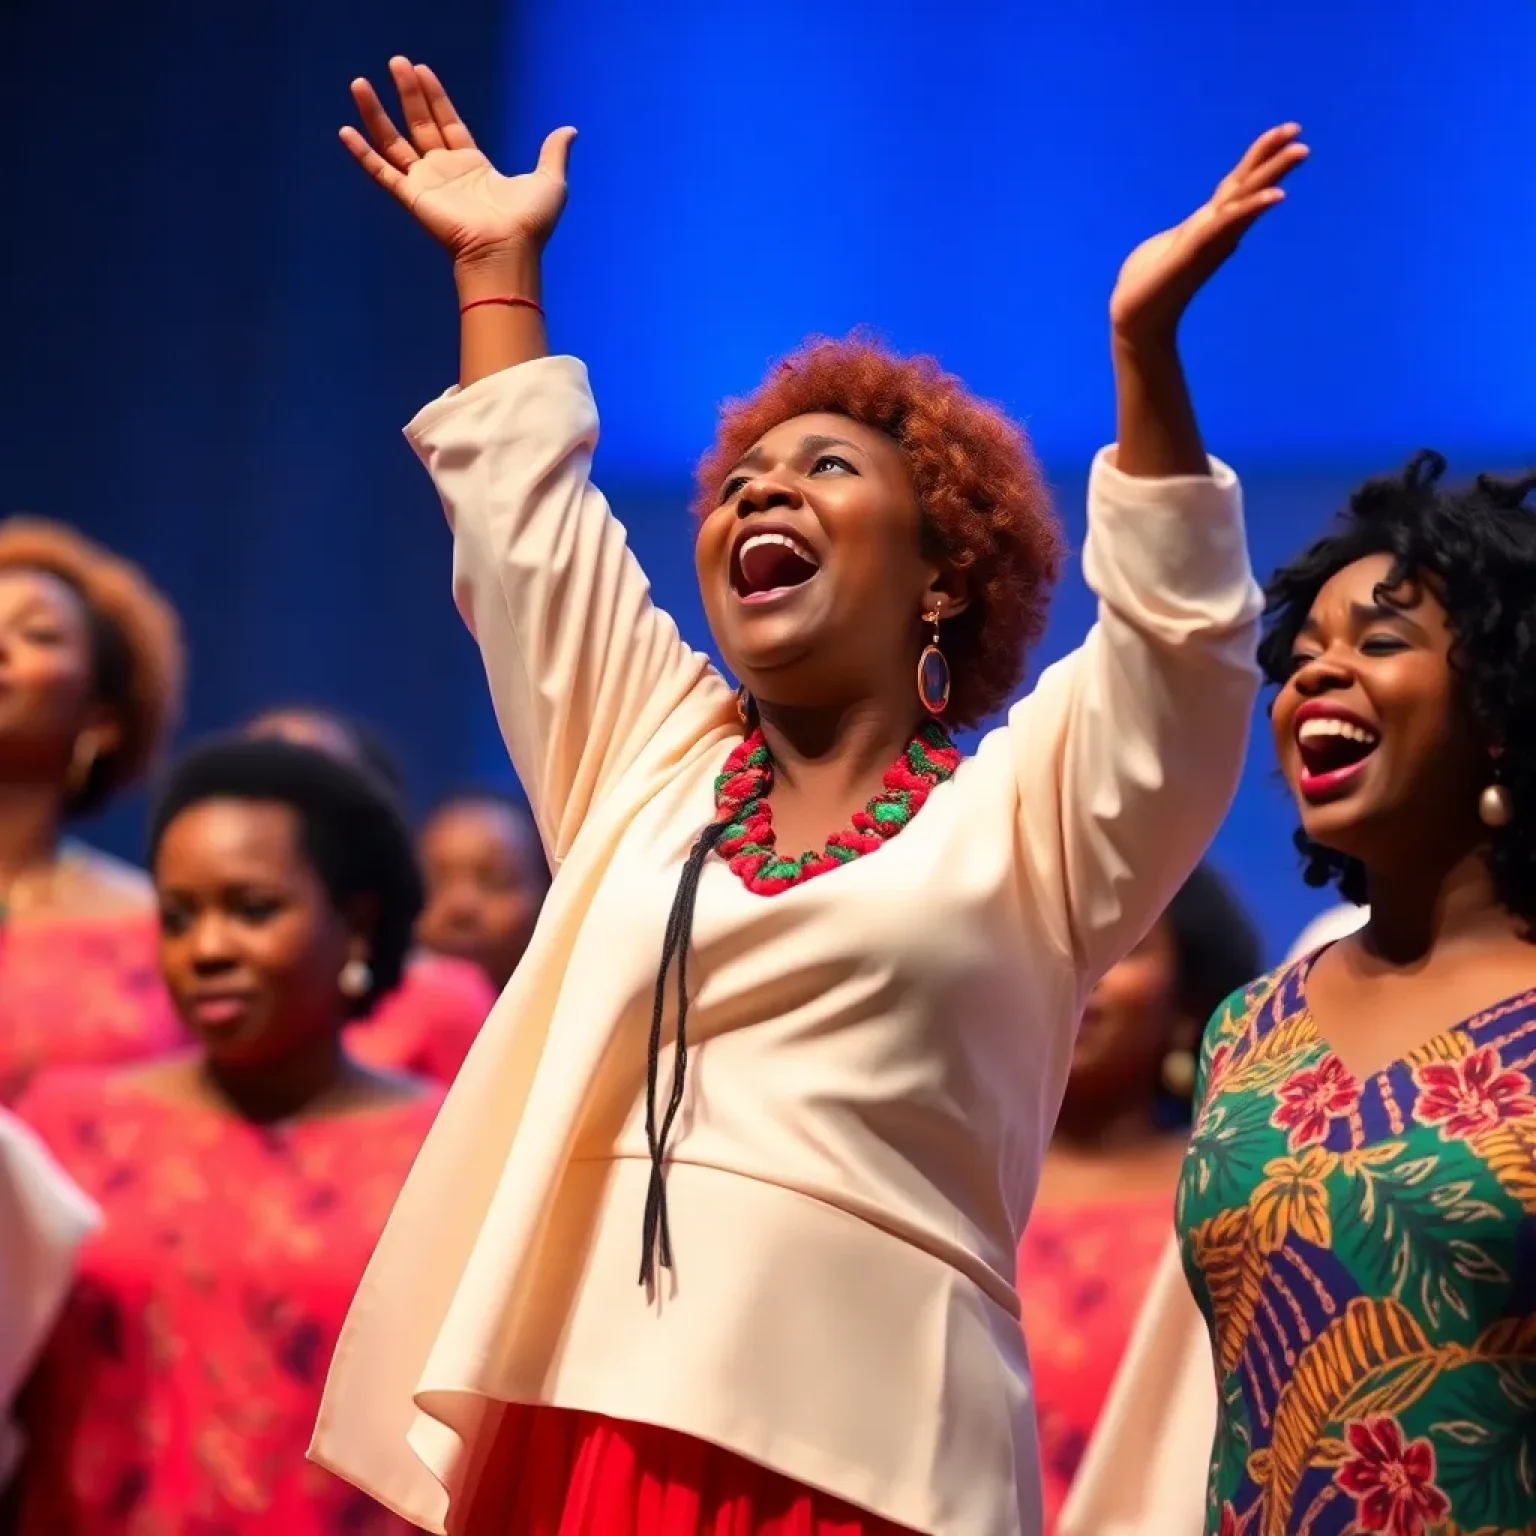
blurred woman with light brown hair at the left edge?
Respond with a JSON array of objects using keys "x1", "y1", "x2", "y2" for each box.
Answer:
[{"x1": 0, "y1": 518, "x2": 184, "y2": 1103}]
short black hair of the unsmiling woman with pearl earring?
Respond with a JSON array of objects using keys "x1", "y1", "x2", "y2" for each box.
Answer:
[{"x1": 149, "y1": 736, "x2": 422, "y2": 1018}]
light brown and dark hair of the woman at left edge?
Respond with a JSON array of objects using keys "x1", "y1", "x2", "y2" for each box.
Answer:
[{"x1": 0, "y1": 518, "x2": 186, "y2": 816}]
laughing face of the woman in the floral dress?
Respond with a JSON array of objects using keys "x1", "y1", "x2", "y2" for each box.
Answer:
[{"x1": 1270, "y1": 554, "x2": 1488, "y2": 868}]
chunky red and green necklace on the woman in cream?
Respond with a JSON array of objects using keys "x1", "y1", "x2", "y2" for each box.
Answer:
[{"x1": 714, "y1": 720, "x2": 960, "y2": 895}]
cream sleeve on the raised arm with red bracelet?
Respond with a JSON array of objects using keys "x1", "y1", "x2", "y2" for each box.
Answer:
[{"x1": 406, "y1": 358, "x2": 728, "y2": 862}]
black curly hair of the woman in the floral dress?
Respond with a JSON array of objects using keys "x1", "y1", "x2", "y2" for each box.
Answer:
[{"x1": 1258, "y1": 449, "x2": 1536, "y2": 920}]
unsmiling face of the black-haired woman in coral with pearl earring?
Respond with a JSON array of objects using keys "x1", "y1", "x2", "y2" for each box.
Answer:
[{"x1": 155, "y1": 800, "x2": 366, "y2": 1063}]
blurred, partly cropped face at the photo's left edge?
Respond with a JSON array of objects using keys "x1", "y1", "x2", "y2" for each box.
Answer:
[{"x1": 0, "y1": 568, "x2": 106, "y2": 777}]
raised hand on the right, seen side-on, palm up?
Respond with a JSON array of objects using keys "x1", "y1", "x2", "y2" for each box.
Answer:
[{"x1": 1109, "y1": 123, "x2": 1309, "y2": 346}]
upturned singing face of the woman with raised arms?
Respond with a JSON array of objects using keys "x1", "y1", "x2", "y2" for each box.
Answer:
[{"x1": 694, "y1": 413, "x2": 960, "y2": 707}]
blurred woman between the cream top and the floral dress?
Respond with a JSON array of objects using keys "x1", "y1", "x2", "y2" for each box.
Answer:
[{"x1": 1018, "y1": 865, "x2": 1261, "y2": 1530}]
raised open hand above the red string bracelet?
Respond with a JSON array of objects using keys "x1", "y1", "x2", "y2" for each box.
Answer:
[{"x1": 341, "y1": 58, "x2": 576, "y2": 269}]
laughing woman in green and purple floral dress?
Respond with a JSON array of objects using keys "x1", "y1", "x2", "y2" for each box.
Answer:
[{"x1": 1178, "y1": 453, "x2": 1536, "y2": 1536}]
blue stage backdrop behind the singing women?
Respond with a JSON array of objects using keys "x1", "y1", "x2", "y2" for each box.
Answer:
[{"x1": 0, "y1": 0, "x2": 1536, "y2": 951}]
